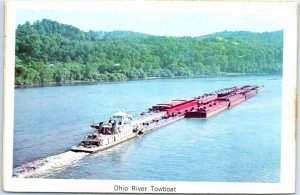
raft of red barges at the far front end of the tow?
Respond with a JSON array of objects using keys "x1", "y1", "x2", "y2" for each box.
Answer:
[{"x1": 154, "y1": 85, "x2": 263, "y2": 118}]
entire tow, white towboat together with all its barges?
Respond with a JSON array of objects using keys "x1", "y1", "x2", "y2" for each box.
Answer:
[{"x1": 71, "y1": 85, "x2": 264, "y2": 153}]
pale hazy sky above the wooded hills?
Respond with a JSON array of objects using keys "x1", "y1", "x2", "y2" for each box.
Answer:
[{"x1": 16, "y1": 1, "x2": 285, "y2": 36}]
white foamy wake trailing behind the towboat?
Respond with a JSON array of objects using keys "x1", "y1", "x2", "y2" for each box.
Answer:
[{"x1": 13, "y1": 151, "x2": 87, "y2": 178}]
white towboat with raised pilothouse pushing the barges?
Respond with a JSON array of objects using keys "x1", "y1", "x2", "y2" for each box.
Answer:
[{"x1": 71, "y1": 111, "x2": 138, "y2": 153}]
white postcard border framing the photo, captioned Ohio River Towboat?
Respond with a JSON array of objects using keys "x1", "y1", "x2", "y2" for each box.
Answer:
[{"x1": 3, "y1": 1, "x2": 297, "y2": 193}]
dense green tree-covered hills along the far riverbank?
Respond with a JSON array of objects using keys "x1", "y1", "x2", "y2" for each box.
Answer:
[{"x1": 15, "y1": 19, "x2": 283, "y2": 85}]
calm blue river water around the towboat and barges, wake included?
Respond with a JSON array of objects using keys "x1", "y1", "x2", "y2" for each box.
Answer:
[{"x1": 13, "y1": 76, "x2": 282, "y2": 183}]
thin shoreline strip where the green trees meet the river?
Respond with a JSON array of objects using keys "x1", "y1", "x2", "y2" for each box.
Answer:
[{"x1": 15, "y1": 73, "x2": 282, "y2": 89}]
